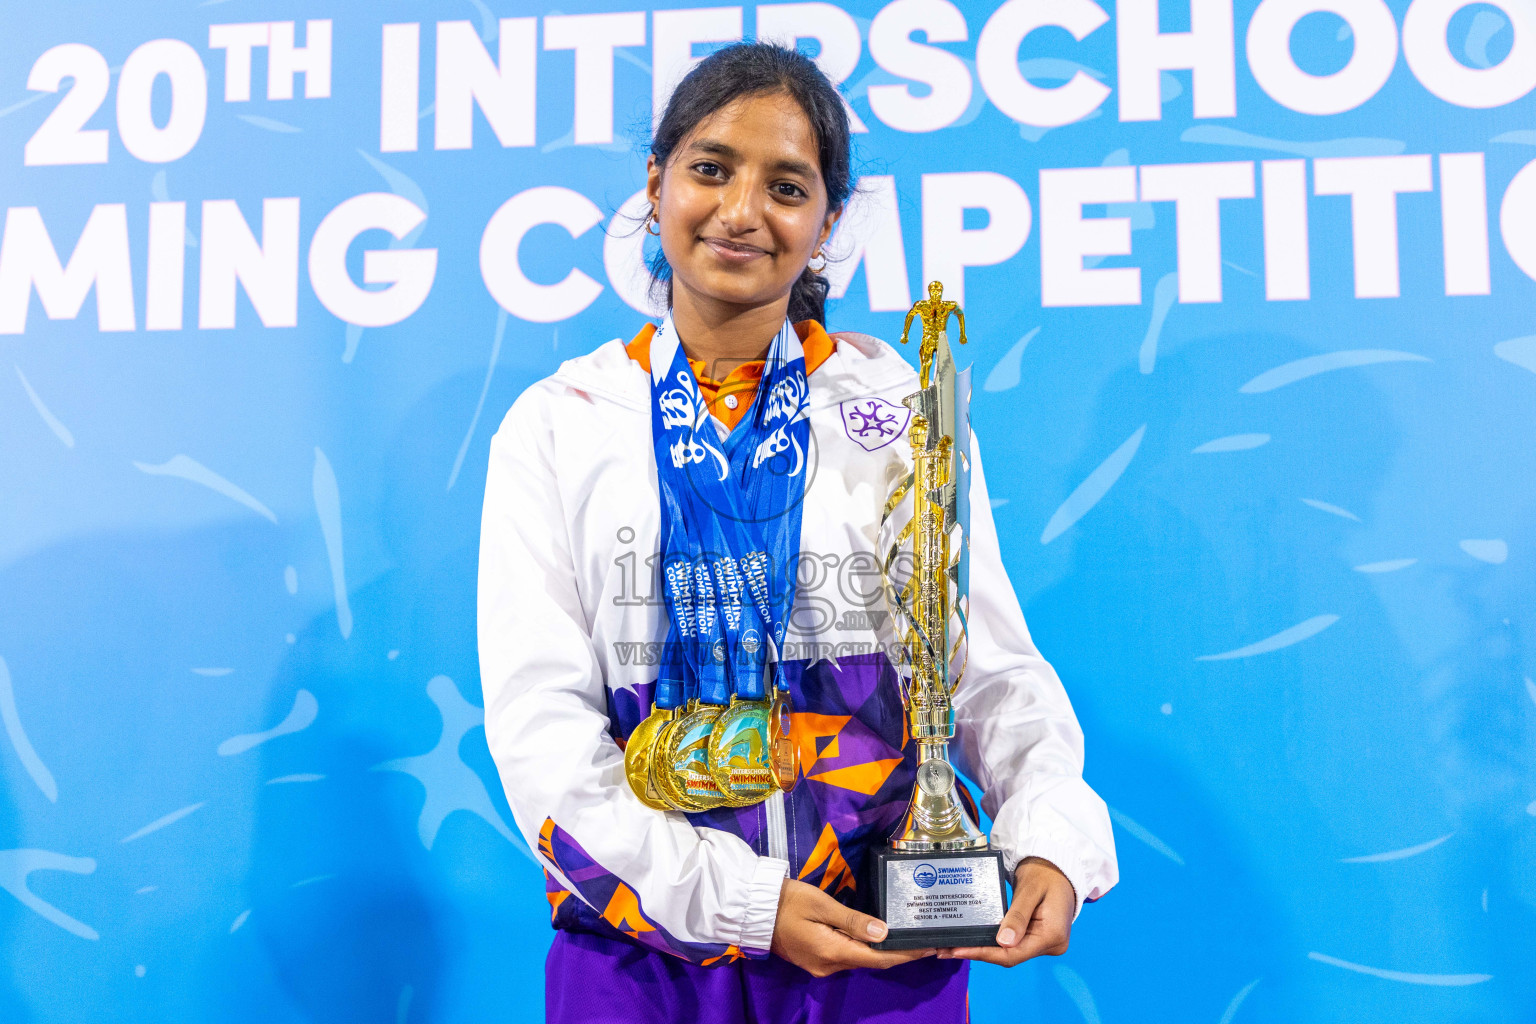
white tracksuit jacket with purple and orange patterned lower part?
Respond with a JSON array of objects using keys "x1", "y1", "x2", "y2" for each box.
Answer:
[{"x1": 479, "y1": 333, "x2": 1117, "y2": 964}]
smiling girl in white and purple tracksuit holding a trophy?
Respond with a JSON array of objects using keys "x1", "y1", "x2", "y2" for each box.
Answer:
[{"x1": 479, "y1": 45, "x2": 1117, "y2": 1024}]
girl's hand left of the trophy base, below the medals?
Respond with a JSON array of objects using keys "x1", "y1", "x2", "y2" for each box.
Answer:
[{"x1": 773, "y1": 878, "x2": 933, "y2": 978}]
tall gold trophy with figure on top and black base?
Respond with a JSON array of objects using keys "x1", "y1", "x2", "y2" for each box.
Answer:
[{"x1": 872, "y1": 281, "x2": 1008, "y2": 949}]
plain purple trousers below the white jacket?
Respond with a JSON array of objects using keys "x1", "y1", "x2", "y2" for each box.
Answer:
[{"x1": 544, "y1": 930, "x2": 969, "y2": 1024}]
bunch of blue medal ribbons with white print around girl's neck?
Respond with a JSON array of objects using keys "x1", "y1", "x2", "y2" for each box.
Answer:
[{"x1": 651, "y1": 313, "x2": 811, "y2": 708}]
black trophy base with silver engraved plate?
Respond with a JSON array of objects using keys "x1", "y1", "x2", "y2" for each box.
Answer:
[{"x1": 869, "y1": 849, "x2": 1008, "y2": 949}]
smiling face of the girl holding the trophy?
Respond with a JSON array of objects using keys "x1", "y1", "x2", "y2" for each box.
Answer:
[{"x1": 647, "y1": 94, "x2": 839, "y2": 316}]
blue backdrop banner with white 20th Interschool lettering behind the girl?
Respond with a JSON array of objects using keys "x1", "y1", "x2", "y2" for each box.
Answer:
[{"x1": 0, "y1": 0, "x2": 1536, "y2": 1024}]
